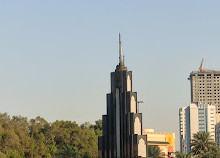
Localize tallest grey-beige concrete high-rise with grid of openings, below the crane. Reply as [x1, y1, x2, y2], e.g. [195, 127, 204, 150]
[189, 69, 220, 115]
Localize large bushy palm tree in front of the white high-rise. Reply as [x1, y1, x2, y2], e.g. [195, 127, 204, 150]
[191, 132, 219, 157]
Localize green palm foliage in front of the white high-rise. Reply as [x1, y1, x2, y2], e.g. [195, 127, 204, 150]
[191, 132, 220, 158]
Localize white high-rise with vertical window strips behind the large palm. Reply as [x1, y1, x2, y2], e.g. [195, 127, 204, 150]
[179, 103, 216, 153]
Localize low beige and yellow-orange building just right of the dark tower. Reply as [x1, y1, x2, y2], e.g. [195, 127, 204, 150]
[143, 129, 175, 158]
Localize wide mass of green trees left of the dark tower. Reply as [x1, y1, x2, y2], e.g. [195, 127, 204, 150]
[0, 113, 102, 158]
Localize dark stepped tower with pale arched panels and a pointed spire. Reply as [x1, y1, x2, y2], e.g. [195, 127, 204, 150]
[98, 34, 147, 158]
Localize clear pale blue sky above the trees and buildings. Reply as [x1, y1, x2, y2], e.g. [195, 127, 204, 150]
[0, 0, 220, 149]
